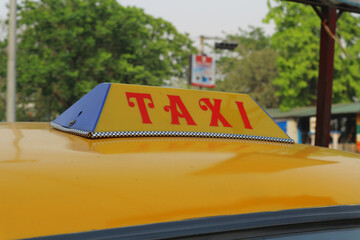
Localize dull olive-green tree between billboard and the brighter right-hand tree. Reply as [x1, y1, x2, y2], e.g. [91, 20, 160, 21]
[217, 27, 279, 108]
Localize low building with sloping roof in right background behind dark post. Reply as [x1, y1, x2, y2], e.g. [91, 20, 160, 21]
[267, 103, 360, 152]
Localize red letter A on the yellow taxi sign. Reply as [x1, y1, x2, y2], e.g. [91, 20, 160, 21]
[164, 95, 196, 125]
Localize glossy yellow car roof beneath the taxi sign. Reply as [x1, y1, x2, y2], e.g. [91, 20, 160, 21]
[0, 123, 360, 239]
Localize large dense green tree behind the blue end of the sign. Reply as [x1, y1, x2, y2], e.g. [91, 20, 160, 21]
[0, 0, 194, 120]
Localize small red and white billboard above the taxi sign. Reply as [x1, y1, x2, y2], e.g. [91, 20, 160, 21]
[190, 55, 215, 88]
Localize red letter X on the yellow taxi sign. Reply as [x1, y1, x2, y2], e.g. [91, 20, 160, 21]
[199, 98, 232, 127]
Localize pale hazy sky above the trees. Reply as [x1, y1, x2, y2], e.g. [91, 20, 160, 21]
[0, 0, 274, 47]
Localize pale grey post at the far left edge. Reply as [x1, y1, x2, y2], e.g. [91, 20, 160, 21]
[6, 0, 16, 122]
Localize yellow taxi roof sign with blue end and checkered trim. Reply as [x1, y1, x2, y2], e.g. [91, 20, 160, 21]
[50, 83, 294, 143]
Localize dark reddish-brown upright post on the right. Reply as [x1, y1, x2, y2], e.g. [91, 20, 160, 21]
[315, 7, 337, 147]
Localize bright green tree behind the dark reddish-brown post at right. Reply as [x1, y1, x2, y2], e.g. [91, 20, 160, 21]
[264, 0, 360, 110]
